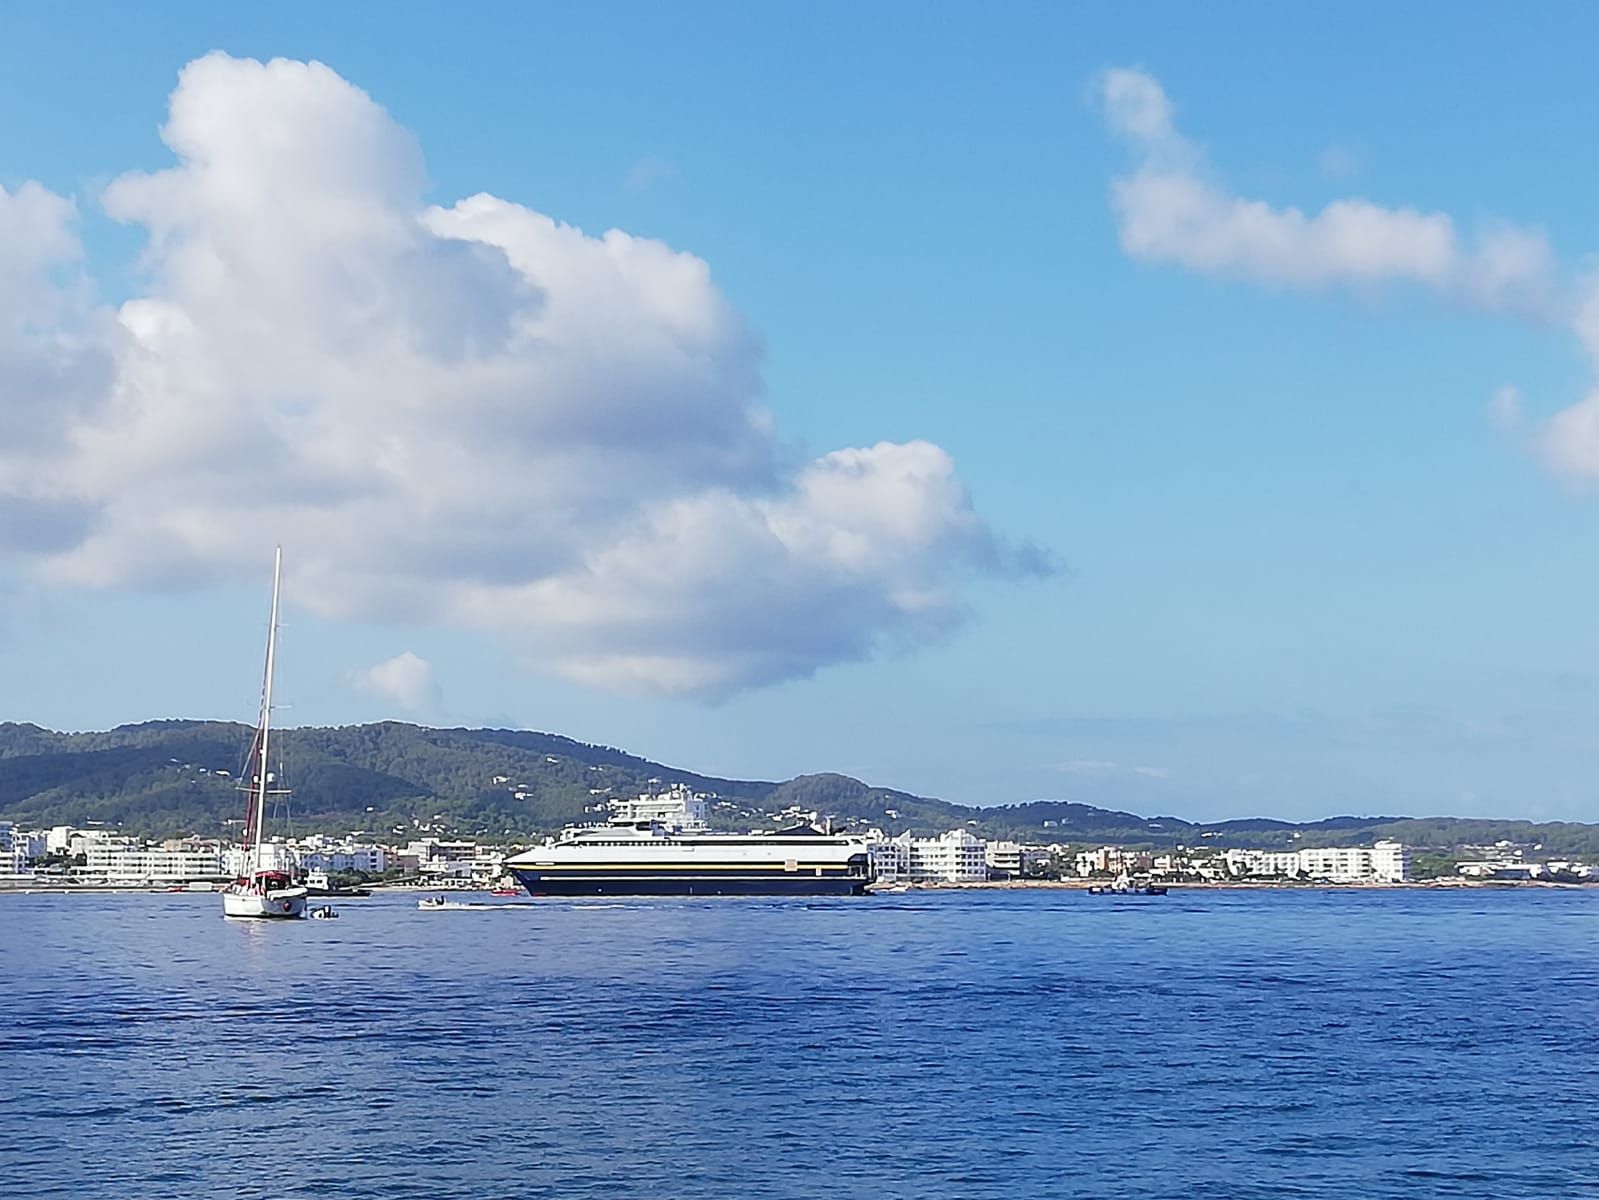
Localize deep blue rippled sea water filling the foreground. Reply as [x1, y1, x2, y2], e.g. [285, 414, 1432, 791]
[0, 890, 1599, 1200]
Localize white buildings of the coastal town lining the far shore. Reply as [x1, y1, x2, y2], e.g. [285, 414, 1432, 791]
[0, 786, 1596, 891]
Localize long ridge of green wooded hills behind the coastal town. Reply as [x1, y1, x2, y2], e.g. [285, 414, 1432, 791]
[0, 720, 1599, 856]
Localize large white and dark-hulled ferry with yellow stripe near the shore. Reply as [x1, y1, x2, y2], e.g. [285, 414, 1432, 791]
[505, 784, 873, 896]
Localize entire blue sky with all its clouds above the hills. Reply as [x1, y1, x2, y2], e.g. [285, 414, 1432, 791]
[0, 3, 1599, 821]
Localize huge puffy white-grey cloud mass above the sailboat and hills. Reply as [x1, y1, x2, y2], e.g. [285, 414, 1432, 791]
[0, 54, 1025, 693]
